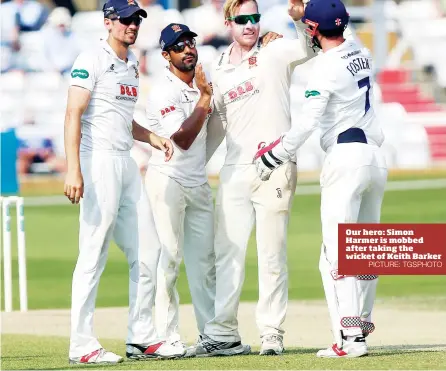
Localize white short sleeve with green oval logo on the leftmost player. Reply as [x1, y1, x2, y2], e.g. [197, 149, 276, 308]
[70, 53, 99, 91]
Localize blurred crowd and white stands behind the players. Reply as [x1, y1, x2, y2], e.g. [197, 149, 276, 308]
[0, 0, 446, 186]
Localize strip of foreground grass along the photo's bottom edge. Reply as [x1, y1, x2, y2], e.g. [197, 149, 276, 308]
[2, 335, 446, 370]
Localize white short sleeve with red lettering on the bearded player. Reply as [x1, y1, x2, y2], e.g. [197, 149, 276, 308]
[146, 86, 187, 138]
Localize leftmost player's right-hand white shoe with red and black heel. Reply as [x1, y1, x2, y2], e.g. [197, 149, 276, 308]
[126, 341, 186, 360]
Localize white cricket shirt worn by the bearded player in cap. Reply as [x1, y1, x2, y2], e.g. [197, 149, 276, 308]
[146, 67, 212, 187]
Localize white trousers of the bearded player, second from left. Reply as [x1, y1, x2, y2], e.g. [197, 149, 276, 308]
[145, 165, 215, 342]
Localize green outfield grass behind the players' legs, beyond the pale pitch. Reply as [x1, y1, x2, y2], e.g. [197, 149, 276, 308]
[2, 189, 446, 309]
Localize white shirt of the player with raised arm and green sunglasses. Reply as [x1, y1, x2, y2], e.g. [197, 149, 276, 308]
[211, 22, 317, 165]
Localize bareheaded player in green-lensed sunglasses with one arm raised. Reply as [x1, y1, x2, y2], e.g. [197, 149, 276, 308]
[202, 0, 316, 355]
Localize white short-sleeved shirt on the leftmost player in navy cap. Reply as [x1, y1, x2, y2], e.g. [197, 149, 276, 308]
[70, 40, 139, 152]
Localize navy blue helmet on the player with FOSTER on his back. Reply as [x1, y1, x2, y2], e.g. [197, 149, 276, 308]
[302, 0, 350, 31]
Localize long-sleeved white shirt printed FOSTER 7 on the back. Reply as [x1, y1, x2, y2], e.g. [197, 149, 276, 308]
[283, 40, 384, 154]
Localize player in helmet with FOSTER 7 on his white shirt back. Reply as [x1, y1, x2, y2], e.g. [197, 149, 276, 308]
[254, 0, 387, 358]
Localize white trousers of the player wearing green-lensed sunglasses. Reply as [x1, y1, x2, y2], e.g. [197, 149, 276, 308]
[205, 162, 297, 342]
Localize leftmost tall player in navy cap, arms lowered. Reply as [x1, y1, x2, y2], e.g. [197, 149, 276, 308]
[64, 0, 184, 364]
